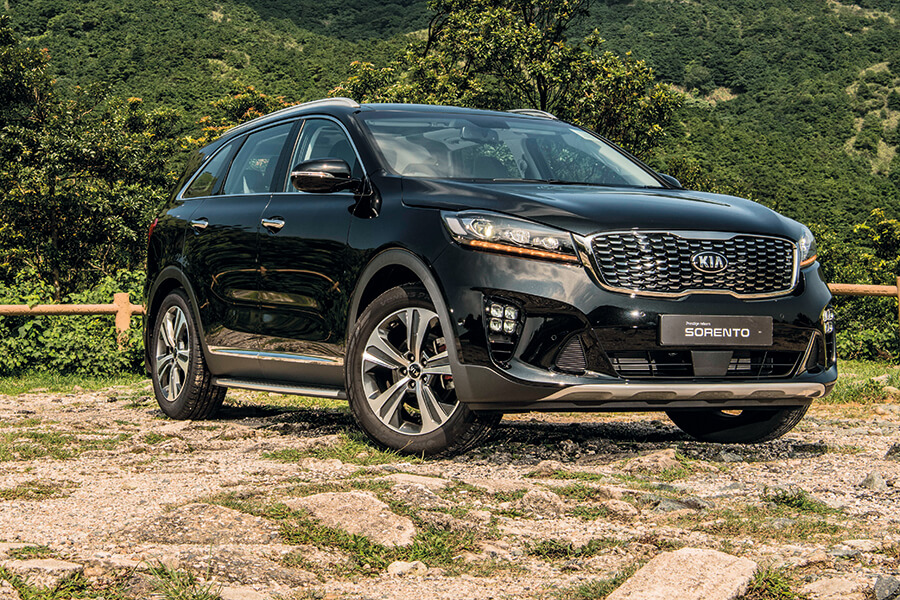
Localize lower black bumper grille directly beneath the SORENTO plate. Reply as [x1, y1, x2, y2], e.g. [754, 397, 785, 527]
[608, 350, 802, 379]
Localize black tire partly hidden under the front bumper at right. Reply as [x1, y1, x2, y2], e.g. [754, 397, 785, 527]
[666, 405, 809, 444]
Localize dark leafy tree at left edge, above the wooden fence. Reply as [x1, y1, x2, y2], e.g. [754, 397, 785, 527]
[0, 21, 178, 300]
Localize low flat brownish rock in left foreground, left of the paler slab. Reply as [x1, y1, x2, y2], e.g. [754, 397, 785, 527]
[122, 503, 280, 546]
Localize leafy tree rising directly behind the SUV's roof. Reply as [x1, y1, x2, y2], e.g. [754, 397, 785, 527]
[332, 0, 680, 153]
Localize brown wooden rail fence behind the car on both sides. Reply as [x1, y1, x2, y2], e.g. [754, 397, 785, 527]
[0, 284, 900, 335]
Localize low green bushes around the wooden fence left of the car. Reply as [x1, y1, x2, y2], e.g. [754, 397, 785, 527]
[0, 270, 144, 376]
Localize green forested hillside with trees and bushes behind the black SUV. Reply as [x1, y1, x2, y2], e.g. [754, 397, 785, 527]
[0, 0, 900, 375]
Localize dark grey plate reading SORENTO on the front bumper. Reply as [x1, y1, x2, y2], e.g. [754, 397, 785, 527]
[659, 315, 772, 348]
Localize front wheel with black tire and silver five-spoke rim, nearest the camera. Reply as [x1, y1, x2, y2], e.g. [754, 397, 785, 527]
[345, 286, 502, 456]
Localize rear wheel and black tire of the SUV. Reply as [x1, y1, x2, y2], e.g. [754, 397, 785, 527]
[150, 290, 226, 420]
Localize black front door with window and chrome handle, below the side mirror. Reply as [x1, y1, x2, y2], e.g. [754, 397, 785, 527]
[253, 117, 362, 386]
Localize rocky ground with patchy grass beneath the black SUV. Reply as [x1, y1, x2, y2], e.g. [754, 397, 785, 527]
[0, 385, 900, 600]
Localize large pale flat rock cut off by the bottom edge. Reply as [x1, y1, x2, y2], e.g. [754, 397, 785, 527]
[607, 548, 757, 600]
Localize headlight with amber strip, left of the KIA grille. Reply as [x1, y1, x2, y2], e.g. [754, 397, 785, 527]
[441, 211, 578, 263]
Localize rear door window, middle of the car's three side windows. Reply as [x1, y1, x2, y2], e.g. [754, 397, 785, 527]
[224, 123, 293, 194]
